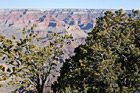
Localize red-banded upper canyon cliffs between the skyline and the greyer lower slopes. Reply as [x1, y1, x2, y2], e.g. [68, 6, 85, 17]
[0, 9, 106, 31]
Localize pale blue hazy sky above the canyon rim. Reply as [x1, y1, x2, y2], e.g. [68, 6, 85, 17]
[0, 0, 140, 10]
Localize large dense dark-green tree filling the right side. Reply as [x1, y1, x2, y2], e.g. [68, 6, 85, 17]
[52, 9, 140, 93]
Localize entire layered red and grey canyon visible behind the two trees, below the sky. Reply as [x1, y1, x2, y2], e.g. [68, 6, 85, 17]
[0, 9, 131, 93]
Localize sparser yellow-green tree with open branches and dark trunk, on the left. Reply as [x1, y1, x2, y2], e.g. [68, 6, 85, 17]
[0, 25, 71, 93]
